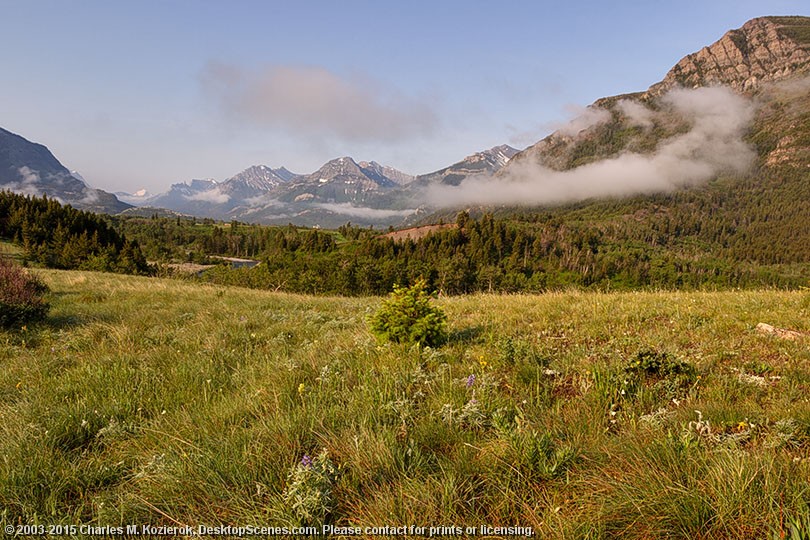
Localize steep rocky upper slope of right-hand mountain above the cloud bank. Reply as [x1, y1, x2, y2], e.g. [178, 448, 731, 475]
[500, 17, 810, 177]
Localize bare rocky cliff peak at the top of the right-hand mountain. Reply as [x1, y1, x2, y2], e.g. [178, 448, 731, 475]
[646, 17, 810, 97]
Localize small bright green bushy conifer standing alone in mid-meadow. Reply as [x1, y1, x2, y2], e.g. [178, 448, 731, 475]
[369, 279, 447, 346]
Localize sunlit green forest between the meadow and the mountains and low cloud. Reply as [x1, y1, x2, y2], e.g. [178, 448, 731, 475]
[116, 179, 810, 295]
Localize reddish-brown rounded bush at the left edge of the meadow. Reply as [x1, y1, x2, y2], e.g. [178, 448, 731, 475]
[0, 257, 50, 328]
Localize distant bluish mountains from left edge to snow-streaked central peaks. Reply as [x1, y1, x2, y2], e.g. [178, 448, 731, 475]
[0, 120, 517, 227]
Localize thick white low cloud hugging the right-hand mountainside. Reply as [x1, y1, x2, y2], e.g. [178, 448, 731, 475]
[425, 87, 755, 207]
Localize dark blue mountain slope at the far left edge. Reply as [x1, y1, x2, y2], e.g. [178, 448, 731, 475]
[0, 128, 131, 214]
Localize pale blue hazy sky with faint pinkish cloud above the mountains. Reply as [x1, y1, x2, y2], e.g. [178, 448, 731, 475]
[0, 0, 810, 192]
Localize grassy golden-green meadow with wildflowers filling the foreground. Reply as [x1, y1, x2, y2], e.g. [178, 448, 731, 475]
[0, 271, 810, 538]
